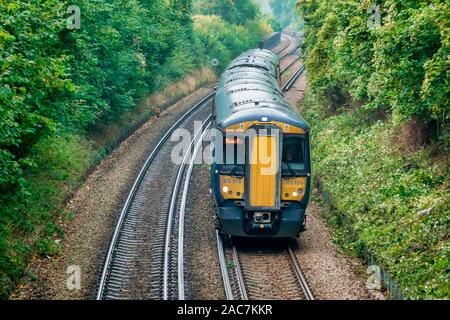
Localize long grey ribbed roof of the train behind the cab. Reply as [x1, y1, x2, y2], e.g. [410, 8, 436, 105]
[215, 49, 309, 131]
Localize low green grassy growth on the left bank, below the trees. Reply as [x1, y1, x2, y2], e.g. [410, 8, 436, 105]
[0, 133, 90, 297]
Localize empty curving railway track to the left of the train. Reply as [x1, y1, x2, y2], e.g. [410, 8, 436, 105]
[97, 31, 302, 300]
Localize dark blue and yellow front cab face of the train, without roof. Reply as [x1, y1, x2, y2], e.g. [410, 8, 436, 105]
[212, 122, 311, 238]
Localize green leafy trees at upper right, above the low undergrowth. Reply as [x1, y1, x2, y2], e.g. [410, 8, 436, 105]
[298, 0, 450, 137]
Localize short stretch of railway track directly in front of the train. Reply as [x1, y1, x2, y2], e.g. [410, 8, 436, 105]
[216, 232, 314, 300]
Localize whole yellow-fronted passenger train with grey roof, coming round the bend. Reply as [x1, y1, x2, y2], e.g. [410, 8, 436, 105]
[211, 49, 312, 238]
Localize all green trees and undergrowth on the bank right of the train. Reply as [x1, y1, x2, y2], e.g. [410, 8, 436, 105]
[298, 0, 450, 299]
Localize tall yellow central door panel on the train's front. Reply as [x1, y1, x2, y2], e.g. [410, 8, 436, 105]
[249, 136, 278, 207]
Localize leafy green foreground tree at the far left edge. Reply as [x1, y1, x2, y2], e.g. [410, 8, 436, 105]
[0, 0, 74, 201]
